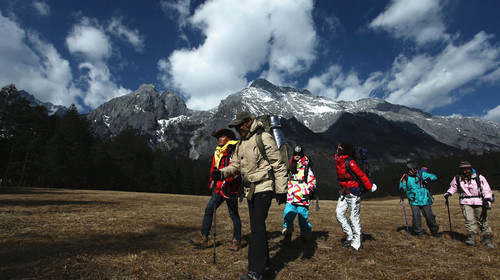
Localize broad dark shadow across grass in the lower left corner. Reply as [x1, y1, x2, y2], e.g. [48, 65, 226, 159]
[0, 224, 199, 279]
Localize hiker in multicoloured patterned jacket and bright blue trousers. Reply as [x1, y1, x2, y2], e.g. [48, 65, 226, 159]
[280, 146, 316, 245]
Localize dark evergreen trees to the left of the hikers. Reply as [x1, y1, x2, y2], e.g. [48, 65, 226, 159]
[0, 85, 210, 194]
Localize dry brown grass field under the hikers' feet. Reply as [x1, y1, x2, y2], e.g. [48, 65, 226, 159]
[0, 188, 500, 280]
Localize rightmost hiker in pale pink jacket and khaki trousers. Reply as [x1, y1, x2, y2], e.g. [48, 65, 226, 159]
[444, 161, 495, 248]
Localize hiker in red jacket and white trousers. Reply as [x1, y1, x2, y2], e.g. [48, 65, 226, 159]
[334, 142, 377, 251]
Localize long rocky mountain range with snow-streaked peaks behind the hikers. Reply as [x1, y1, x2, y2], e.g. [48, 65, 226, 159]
[88, 79, 500, 162]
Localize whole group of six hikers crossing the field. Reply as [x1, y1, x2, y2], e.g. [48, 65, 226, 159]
[188, 111, 494, 280]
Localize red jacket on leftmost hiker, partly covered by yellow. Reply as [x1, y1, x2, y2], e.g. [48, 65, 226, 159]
[207, 141, 241, 199]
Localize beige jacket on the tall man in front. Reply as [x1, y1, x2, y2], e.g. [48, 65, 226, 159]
[220, 119, 287, 199]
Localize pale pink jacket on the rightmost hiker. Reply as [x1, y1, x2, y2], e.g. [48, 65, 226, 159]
[447, 173, 492, 206]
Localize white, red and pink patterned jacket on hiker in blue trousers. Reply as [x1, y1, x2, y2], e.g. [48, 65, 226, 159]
[287, 156, 316, 206]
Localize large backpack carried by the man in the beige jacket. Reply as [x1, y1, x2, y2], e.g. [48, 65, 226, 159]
[255, 115, 289, 169]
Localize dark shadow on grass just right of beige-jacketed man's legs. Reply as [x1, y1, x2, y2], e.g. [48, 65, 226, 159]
[265, 231, 328, 279]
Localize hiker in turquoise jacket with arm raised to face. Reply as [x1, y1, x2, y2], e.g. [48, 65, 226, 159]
[399, 160, 441, 237]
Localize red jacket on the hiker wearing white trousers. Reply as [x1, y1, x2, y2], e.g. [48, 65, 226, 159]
[335, 155, 372, 195]
